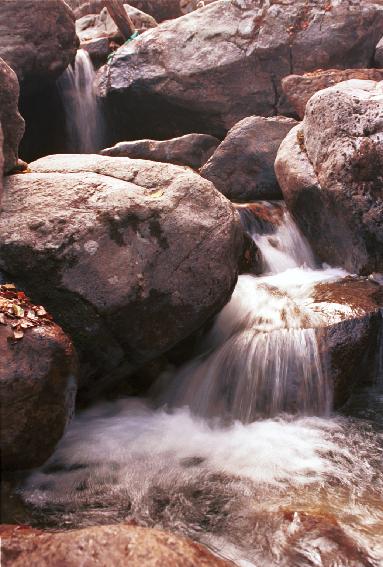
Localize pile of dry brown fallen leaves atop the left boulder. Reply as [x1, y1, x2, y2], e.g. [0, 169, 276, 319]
[0, 284, 52, 341]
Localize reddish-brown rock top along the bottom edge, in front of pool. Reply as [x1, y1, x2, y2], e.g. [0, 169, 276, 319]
[0, 524, 231, 567]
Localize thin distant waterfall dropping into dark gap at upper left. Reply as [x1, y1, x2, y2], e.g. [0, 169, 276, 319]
[57, 49, 103, 153]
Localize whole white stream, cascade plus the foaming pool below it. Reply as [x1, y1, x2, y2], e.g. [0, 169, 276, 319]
[4, 203, 383, 567]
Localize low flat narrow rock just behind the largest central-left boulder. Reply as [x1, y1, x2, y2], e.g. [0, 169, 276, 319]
[100, 134, 219, 169]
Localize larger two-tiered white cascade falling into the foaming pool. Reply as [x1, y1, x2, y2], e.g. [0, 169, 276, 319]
[161, 202, 334, 423]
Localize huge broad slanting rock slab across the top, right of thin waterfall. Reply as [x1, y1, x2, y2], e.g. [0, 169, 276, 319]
[99, 0, 383, 140]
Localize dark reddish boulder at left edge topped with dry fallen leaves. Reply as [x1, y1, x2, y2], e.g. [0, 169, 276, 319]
[0, 284, 76, 470]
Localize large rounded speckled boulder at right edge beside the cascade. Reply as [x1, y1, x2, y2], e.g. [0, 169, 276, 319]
[275, 80, 383, 274]
